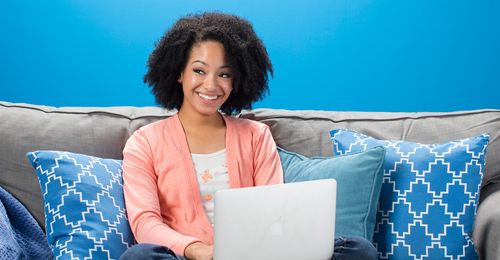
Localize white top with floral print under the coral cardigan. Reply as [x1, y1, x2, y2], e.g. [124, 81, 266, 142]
[191, 149, 229, 226]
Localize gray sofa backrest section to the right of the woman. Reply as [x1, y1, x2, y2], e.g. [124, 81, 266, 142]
[242, 109, 500, 197]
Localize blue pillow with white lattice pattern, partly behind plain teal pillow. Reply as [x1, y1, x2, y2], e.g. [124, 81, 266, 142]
[330, 129, 489, 259]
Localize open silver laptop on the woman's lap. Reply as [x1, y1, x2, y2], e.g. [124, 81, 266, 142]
[214, 179, 337, 260]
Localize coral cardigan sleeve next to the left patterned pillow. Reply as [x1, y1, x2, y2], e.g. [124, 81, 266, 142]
[123, 129, 200, 255]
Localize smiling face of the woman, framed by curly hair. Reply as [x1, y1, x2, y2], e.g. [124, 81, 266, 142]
[179, 41, 233, 116]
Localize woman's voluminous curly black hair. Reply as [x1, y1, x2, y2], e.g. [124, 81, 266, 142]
[144, 12, 273, 114]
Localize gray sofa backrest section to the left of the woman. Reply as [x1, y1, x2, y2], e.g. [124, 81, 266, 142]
[0, 102, 173, 227]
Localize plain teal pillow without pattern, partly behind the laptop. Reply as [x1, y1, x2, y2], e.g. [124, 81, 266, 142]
[278, 147, 385, 240]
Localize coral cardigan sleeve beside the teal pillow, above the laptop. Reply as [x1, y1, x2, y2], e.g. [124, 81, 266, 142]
[254, 125, 283, 186]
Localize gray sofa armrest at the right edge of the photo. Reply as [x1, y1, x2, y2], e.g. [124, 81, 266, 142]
[473, 190, 500, 260]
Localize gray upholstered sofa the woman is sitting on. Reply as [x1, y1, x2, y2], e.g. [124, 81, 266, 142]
[0, 102, 500, 259]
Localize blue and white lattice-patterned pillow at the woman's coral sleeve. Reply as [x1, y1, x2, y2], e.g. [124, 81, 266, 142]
[27, 151, 134, 259]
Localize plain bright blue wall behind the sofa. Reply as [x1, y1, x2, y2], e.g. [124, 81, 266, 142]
[0, 0, 500, 111]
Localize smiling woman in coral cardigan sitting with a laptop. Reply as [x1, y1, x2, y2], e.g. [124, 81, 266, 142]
[122, 13, 376, 259]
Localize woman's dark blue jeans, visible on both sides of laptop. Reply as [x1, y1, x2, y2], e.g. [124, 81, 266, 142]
[120, 237, 377, 260]
